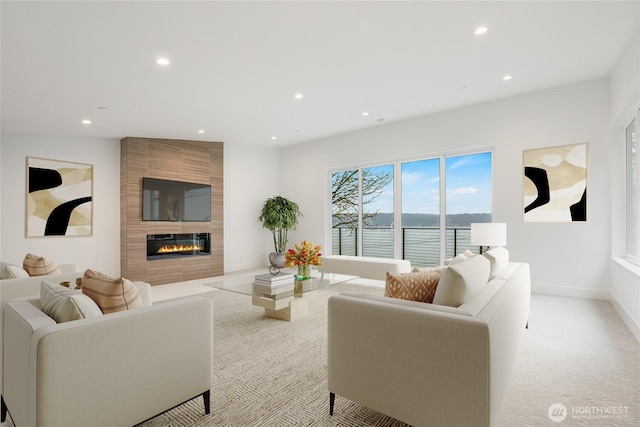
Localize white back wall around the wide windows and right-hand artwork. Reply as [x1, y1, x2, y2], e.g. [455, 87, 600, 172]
[281, 78, 611, 299]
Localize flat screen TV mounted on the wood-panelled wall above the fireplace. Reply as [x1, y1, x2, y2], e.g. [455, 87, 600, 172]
[142, 178, 211, 222]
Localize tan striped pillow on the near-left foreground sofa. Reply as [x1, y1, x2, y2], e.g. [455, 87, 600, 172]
[82, 270, 142, 314]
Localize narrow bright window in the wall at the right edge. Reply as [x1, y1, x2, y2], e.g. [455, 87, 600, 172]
[626, 116, 640, 265]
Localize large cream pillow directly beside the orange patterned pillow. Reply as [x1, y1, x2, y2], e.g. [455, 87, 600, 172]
[433, 256, 490, 307]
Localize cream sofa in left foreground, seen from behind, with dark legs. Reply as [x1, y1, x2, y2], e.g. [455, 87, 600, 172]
[1, 296, 213, 427]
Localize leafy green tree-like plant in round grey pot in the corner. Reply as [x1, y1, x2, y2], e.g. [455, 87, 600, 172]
[258, 196, 302, 268]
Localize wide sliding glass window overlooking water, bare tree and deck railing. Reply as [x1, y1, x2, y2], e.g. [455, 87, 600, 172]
[331, 152, 492, 267]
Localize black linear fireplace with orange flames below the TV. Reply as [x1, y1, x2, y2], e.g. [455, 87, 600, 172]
[147, 233, 211, 260]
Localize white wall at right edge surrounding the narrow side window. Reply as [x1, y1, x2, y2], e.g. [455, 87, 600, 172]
[610, 34, 640, 341]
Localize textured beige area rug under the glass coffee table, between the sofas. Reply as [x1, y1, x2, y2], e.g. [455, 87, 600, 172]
[141, 283, 406, 427]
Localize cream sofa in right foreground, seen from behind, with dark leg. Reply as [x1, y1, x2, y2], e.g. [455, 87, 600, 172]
[327, 254, 531, 427]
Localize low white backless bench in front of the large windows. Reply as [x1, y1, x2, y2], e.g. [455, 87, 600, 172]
[318, 255, 411, 280]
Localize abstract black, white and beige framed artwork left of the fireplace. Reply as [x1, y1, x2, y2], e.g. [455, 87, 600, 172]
[26, 157, 93, 237]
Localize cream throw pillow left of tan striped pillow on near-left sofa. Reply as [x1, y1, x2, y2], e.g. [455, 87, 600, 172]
[40, 280, 102, 323]
